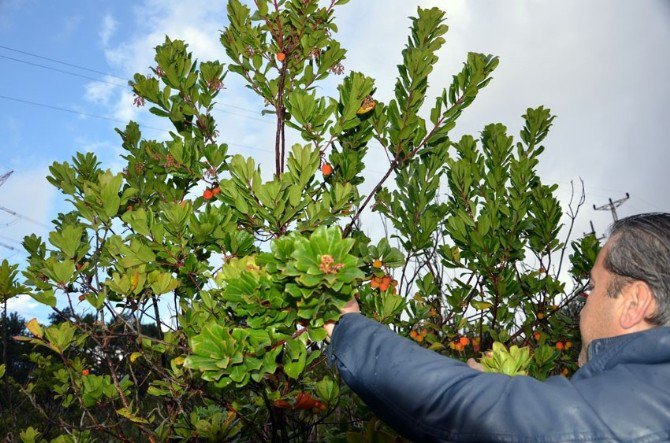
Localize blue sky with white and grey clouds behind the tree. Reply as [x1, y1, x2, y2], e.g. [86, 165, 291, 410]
[0, 0, 670, 319]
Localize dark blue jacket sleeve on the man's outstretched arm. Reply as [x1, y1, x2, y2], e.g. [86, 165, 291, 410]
[327, 314, 613, 442]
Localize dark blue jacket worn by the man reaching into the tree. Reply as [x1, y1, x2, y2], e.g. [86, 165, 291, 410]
[327, 314, 670, 442]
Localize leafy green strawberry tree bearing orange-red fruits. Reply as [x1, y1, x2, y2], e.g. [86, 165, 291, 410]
[0, 0, 598, 441]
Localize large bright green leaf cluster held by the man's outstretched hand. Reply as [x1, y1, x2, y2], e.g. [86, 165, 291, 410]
[184, 227, 364, 387]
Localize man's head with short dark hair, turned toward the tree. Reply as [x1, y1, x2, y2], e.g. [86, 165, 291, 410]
[580, 214, 670, 364]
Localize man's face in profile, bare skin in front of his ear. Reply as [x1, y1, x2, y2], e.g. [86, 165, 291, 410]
[579, 243, 618, 365]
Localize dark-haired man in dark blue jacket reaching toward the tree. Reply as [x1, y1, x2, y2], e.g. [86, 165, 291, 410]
[327, 214, 670, 442]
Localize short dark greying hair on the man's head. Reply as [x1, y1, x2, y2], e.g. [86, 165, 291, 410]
[603, 213, 670, 326]
